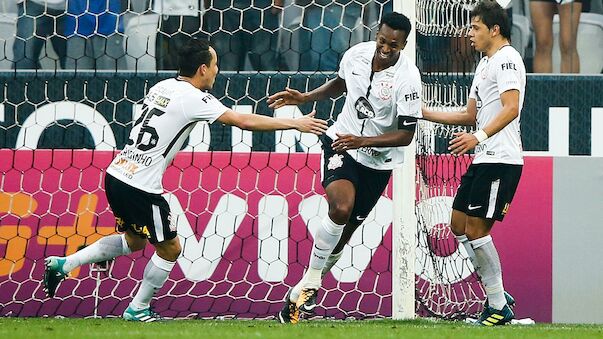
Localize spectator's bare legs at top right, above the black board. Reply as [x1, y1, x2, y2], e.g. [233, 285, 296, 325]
[530, 0, 588, 73]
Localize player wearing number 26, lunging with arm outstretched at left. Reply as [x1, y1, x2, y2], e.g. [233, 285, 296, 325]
[44, 39, 327, 322]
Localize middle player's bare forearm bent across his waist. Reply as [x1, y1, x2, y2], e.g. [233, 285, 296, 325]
[331, 130, 415, 152]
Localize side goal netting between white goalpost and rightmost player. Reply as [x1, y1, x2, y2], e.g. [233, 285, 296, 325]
[416, 0, 485, 319]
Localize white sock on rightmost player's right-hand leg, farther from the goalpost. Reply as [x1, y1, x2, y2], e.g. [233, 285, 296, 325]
[471, 235, 507, 310]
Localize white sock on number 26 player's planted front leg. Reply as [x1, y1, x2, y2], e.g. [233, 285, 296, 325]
[130, 253, 176, 311]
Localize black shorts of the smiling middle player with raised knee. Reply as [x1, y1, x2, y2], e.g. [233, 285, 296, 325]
[321, 136, 392, 225]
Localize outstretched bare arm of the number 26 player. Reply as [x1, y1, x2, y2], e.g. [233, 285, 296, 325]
[218, 110, 328, 135]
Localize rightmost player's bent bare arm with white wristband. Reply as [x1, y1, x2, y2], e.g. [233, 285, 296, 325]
[448, 90, 519, 155]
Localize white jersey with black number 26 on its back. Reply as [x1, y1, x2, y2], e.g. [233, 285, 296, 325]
[107, 79, 228, 194]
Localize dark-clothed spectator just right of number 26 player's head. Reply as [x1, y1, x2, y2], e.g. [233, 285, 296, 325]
[203, 0, 283, 71]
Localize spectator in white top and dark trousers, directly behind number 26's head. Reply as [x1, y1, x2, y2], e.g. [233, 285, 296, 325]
[153, 0, 203, 70]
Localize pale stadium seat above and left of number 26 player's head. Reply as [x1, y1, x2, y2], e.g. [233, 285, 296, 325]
[124, 14, 159, 71]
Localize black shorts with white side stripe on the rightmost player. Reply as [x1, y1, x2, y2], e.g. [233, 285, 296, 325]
[452, 164, 523, 221]
